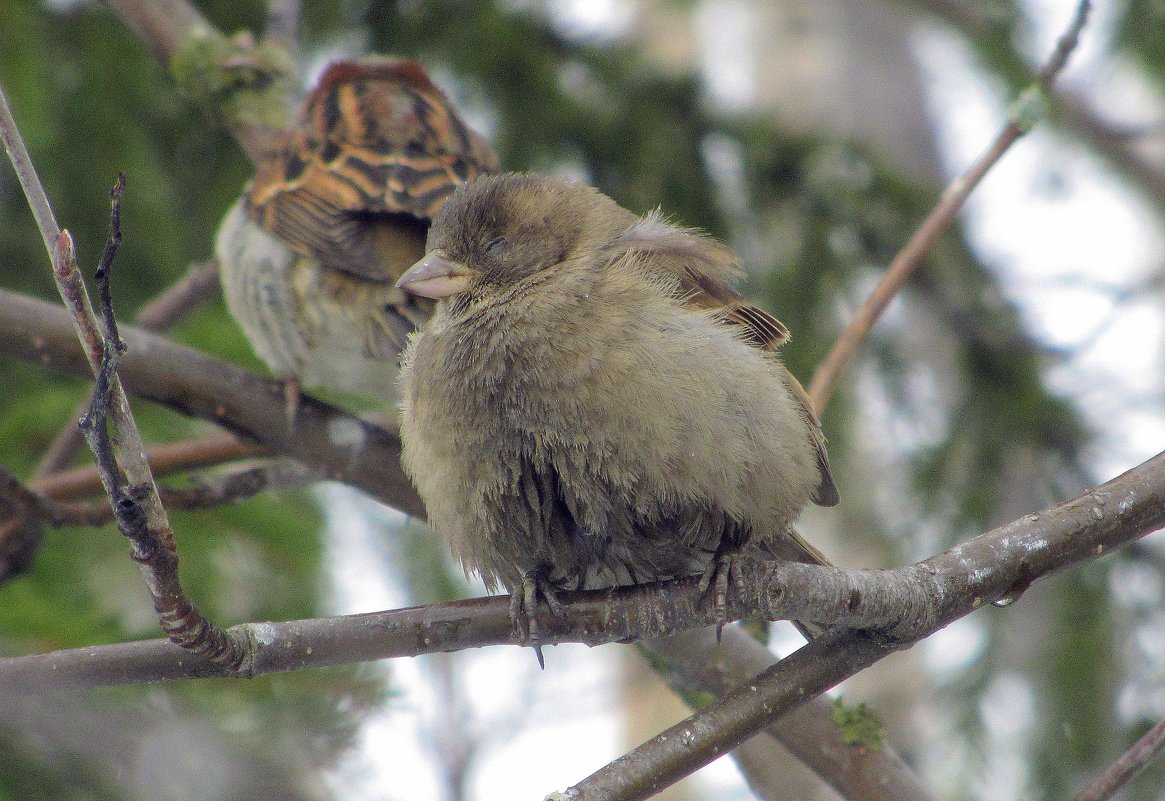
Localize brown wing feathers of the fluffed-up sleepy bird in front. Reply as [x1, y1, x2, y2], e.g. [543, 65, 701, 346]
[608, 211, 838, 506]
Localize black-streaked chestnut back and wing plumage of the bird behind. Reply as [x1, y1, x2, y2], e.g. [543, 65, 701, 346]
[247, 58, 499, 282]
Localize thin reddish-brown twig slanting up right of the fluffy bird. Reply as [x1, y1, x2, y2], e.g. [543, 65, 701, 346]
[809, 0, 1090, 413]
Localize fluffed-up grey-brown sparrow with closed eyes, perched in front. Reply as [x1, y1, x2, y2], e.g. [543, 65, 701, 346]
[397, 173, 838, 662]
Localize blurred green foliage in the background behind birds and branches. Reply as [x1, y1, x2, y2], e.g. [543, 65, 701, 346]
[0, 0, 1165, 801]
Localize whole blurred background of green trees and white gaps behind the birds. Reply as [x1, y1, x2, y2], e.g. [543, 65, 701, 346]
[0, 0, 1165, 800]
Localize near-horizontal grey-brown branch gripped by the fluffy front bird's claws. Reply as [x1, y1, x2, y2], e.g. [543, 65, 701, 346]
[0, 453, 1165, 689]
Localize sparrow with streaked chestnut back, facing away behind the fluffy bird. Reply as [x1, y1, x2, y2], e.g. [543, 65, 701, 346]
[216, 57, 497, 407]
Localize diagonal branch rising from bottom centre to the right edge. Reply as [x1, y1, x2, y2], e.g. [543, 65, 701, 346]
[564, 453, 1165, 801]
